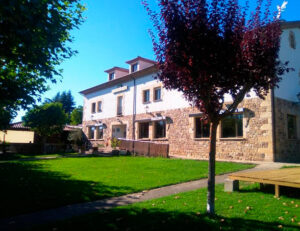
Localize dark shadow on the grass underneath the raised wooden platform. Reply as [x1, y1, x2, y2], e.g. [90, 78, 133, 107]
[239, 183, 300, 198]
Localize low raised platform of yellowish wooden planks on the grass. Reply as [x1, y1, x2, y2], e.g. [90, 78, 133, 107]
[229, 168, 300, 197]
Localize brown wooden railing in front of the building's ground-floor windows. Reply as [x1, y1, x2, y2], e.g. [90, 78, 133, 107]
[119, 139, 169, 158]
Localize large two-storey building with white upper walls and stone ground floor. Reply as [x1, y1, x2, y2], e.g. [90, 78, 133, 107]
[81, 22, 300, 161]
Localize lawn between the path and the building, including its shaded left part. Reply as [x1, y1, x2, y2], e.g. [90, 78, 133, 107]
[0, 157, 253, 217]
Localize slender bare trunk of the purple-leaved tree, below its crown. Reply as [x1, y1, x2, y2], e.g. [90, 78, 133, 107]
[207, 122, 219, 215]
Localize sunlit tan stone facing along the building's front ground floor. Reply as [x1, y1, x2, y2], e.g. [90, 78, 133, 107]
[83, 95, 273, 161]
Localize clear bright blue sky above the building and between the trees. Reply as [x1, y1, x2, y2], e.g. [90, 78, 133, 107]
[14, 0, 300, 121]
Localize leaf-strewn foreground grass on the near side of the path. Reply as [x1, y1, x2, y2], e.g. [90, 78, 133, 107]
[36, 184, 300, 231]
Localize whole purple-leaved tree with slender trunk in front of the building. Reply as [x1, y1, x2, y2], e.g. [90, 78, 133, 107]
[143, 0, 289, 214]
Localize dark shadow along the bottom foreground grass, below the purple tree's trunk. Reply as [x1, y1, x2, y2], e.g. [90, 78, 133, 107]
[38, 208, 298, 231]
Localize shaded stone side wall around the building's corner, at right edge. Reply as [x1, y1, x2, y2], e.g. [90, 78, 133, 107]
[275, 98, 300, 162]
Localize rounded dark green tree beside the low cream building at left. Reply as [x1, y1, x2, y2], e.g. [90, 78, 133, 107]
[23, 103, 67, 137]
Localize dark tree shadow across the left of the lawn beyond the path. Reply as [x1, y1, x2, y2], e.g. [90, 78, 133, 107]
[0, 161, 133, 218]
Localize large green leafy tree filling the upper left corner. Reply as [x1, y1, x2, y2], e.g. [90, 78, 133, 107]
[0, 0, 84, 129]
